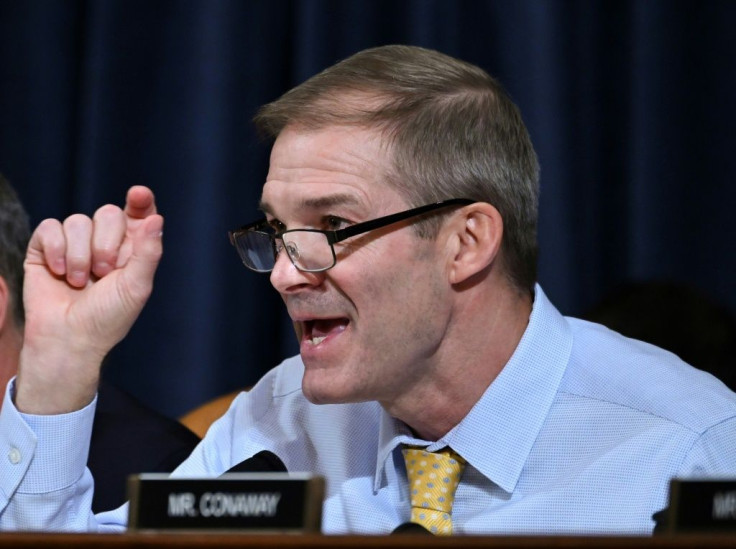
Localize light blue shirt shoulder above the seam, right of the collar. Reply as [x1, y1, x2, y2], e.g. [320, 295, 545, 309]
[562, 317, 736, 433]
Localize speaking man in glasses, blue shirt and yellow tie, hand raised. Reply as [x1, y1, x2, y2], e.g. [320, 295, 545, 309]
[0, 46, 736, 534]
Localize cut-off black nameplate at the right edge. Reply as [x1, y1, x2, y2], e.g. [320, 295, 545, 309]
[667, 479, 736, 532]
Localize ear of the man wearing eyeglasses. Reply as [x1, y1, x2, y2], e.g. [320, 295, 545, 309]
[449, 202, 503, 284]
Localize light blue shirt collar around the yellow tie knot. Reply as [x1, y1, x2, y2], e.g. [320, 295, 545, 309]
[374, 285, 572, 492]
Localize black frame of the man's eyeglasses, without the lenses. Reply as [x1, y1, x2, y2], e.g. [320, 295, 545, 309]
[228, 198, 477, 273]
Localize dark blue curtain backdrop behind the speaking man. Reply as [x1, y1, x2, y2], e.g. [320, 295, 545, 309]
[0, 0, 736, 415]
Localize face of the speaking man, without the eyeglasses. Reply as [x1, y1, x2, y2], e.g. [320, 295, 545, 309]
[262, 127, 451, 403]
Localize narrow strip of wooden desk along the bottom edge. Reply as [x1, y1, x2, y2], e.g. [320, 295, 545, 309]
[0, 533, 736, 549]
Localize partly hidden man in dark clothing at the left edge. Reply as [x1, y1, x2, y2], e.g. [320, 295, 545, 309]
[0, 175, 199, 511]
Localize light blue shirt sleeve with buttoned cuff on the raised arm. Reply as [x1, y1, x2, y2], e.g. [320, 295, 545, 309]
[0, 380, 127, 531]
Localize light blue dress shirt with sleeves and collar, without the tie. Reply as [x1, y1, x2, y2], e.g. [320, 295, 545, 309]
[0, 287, 736, 534]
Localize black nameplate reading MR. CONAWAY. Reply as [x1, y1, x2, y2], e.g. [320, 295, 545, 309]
[128, 473, 325, 533]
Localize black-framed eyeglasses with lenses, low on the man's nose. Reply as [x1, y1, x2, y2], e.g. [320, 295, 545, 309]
[228, 198, 475, 273]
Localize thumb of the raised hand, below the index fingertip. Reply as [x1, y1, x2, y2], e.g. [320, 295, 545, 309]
[125, 215, 164, 304]
